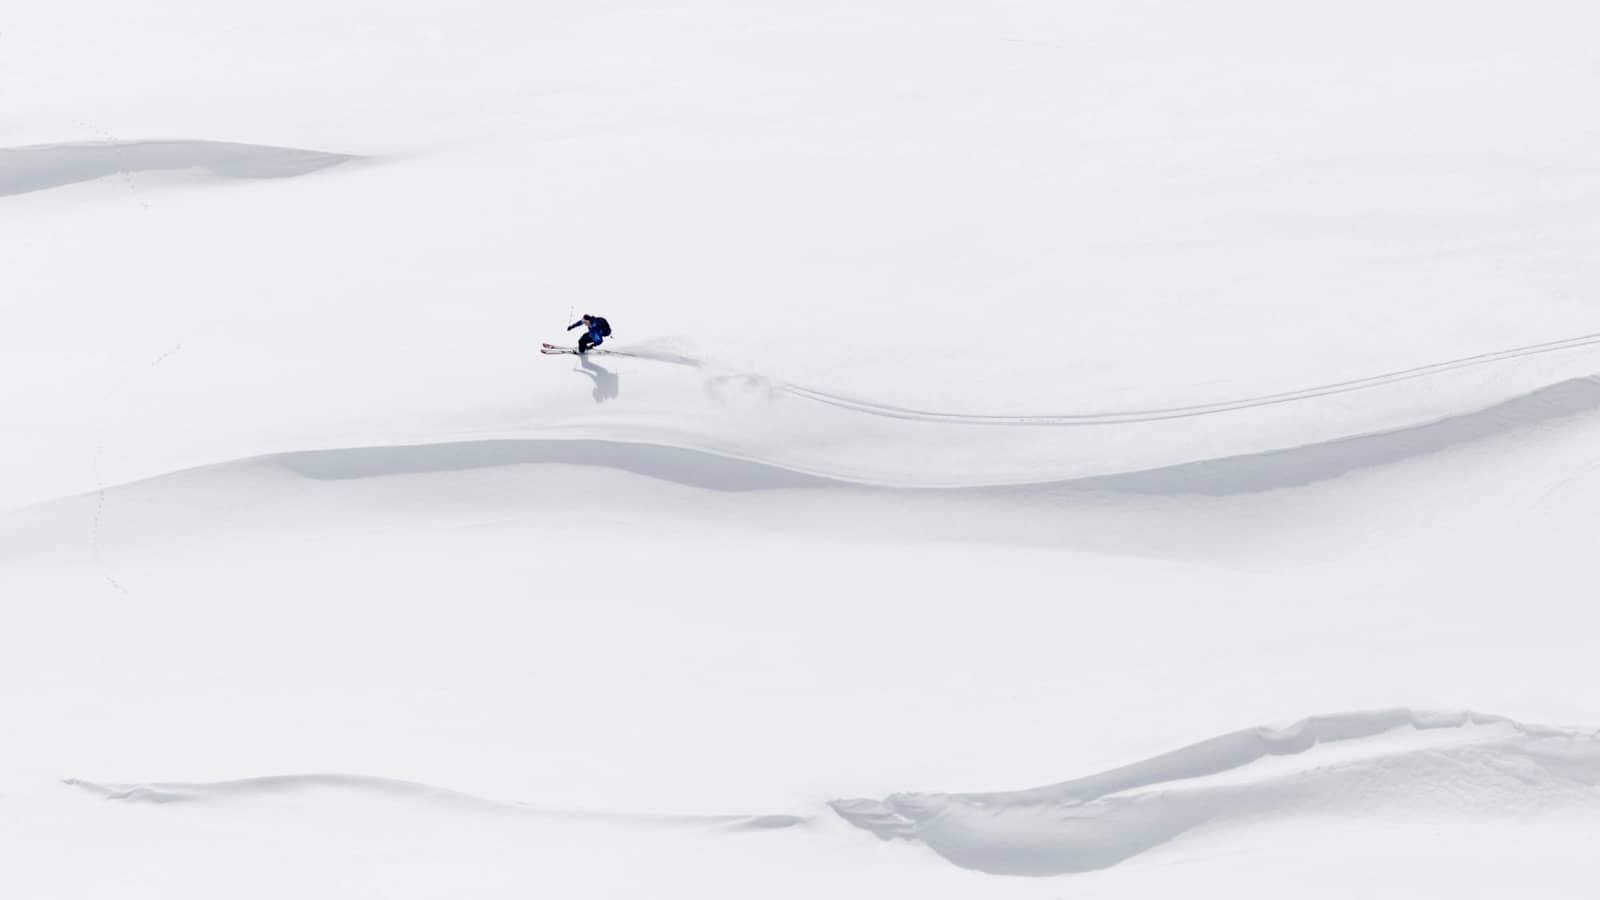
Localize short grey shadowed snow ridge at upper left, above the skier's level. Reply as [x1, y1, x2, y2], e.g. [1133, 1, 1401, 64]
[0, 141, 358, 197]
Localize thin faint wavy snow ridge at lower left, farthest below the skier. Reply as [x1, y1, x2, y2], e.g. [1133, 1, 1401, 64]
[64, 773, 806, 831]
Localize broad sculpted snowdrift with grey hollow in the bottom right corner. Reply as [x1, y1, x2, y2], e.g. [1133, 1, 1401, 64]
[832, 709, 1600, 876]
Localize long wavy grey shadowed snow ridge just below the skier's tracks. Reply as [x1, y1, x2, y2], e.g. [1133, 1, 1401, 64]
[18, 368, 1600, 508]
